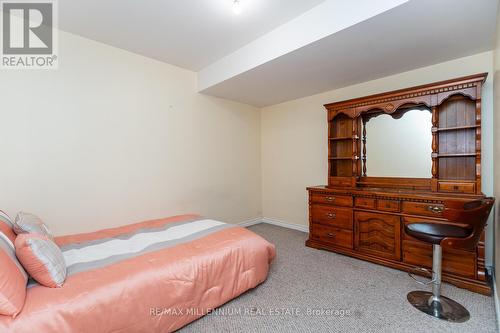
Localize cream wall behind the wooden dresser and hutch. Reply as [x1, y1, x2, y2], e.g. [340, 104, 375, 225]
[261, 52, 493, 265]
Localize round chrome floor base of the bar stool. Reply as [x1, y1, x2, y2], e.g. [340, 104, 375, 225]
[406, 291, 470, 323]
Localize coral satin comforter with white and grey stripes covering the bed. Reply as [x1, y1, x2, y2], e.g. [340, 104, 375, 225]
[0, 215, 275, 333]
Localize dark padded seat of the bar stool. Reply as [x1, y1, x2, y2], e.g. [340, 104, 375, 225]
[405, 223, 471, 245]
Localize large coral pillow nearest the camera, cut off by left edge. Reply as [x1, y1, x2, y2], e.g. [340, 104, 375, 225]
[0, 232, 28, 317]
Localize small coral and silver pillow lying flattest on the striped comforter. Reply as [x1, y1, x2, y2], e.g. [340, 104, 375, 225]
[15, 234, 66, 288]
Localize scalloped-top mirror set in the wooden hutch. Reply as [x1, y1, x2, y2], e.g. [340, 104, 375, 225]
[362, 108, 432, 178]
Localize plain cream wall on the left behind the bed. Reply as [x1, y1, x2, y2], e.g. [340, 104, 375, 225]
[0, 32, 261, 234]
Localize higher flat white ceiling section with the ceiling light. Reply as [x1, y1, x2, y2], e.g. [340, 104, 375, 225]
[58, 0, 324, 71]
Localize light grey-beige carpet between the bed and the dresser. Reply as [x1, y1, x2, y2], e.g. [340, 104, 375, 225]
[181, 224, 496, 333]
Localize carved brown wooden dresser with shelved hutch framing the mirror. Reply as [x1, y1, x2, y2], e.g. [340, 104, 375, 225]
[306, 73, 491, 294]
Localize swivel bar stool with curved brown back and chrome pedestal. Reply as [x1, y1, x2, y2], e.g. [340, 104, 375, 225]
[405, 198, 495, 322]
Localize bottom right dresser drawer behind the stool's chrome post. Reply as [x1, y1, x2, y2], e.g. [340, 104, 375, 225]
[403, 240, 476, 279]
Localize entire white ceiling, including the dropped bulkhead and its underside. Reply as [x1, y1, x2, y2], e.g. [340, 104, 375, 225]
[59, 0, 498, 107]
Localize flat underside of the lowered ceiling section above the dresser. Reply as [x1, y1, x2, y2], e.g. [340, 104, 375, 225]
[203, 0, 497, 107]
